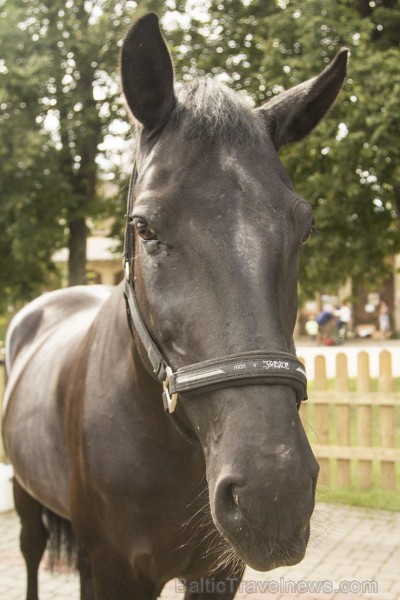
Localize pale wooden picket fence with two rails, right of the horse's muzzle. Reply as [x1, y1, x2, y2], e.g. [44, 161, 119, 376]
[309, 351, 400, 491]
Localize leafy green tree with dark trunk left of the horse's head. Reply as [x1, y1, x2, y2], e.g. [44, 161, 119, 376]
[0, 0, 145, 305]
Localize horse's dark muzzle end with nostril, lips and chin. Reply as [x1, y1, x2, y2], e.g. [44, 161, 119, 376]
[212, 458, 318, 571]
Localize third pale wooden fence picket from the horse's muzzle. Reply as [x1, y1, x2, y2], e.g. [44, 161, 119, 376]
[357, 352, 372, 489]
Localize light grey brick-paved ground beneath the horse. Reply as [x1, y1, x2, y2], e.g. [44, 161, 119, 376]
[0, 504, 400, 600]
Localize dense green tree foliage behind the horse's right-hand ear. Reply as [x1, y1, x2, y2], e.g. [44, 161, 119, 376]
[256, 0, 400, 293]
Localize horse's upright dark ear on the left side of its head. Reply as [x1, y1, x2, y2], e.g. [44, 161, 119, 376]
[121, 13, 175, 131]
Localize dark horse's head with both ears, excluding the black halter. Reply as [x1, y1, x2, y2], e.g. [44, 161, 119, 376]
[121, 14, 347, 570]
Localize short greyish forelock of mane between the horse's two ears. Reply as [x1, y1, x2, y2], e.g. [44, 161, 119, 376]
[170, 77, 265, 143]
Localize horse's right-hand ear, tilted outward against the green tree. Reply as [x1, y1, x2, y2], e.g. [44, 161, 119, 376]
[258, 48, 348, 149]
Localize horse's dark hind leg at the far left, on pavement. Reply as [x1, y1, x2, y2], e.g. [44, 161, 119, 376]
[14, 478, 48, 600]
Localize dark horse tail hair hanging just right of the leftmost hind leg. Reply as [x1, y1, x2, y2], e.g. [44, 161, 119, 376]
[43, 507, 79, 571]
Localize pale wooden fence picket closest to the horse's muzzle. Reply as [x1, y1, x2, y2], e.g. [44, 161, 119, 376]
[314, 355, 329, 486]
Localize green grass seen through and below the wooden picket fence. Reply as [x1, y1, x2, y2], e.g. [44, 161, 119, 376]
[305, 378, 400, 511]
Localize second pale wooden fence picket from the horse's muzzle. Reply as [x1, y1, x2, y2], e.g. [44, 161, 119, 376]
[335, 352, 351, 488]
